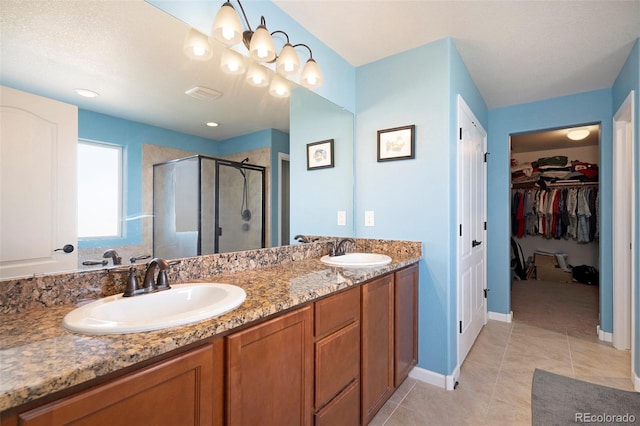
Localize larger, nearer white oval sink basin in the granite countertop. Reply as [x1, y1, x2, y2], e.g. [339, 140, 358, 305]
[62, 283, 247, 334]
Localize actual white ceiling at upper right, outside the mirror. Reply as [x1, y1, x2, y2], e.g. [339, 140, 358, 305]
[274, 0, 640, 109]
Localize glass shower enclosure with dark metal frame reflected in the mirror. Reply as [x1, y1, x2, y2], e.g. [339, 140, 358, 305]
[153, 155, 265, 259]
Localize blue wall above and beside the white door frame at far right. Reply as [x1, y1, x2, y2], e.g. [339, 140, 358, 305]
[612, 39, 640, 374]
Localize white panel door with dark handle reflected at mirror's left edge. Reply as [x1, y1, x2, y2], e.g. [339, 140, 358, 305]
[0, 87, 78, 278]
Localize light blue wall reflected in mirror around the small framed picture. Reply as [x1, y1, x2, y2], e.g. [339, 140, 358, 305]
[289, 90, 354, 241]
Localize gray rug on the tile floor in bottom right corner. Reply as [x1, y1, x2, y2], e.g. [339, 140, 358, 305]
[531, 369, 640, 426]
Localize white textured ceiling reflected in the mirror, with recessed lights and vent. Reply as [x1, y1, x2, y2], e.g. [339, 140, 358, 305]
[0, 0, 289, 140]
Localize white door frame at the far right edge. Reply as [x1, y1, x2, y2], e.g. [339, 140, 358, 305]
[612, 90, 639, 380]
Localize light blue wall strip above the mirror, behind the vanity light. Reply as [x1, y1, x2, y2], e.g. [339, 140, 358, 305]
[147, 0, 355, 112]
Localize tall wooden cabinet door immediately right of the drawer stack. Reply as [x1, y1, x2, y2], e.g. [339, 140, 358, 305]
[360, 274, 394, 424]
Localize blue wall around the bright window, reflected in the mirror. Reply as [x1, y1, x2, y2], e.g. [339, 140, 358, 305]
[78, 109, 216, 248]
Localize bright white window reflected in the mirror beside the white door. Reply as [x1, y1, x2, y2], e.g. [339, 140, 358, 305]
[78, 140, 123, 239]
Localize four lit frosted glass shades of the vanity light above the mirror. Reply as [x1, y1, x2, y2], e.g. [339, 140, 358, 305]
[208, 0, 322, 88]
